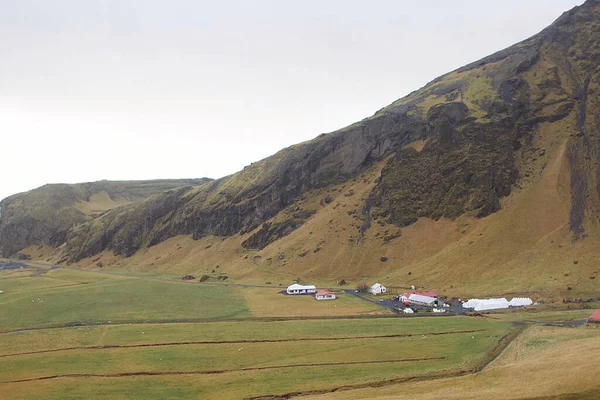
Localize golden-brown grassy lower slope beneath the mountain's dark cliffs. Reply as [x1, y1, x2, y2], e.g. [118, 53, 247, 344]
[68, 126, 600, 301]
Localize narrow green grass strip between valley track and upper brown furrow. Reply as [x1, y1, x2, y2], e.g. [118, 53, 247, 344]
[0, 317, 496, 356]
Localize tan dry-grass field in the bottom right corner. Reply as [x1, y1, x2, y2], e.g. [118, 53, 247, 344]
[308, 326, 600, 400]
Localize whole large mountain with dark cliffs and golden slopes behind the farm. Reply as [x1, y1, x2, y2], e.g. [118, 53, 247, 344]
[0, 0, 600, 295]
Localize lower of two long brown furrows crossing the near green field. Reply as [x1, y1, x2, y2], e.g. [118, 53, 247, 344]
[0, 357, 447, 385]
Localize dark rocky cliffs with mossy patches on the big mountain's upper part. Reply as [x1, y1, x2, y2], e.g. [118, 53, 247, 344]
[0, 0, 600, 268]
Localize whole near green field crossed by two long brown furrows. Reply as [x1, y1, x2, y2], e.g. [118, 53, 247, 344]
[0, 318, 510, 399]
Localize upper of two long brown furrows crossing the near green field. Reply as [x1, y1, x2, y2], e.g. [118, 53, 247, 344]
[0, 329, 486, 358]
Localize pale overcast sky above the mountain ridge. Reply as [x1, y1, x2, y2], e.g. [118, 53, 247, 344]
[0, 0, 583, 199]
